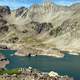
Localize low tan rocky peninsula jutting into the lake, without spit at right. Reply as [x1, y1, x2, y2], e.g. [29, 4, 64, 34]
[15, 48, 64, 58]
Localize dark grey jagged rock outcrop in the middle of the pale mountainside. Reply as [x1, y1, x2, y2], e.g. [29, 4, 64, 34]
[26, 21, 53, 34]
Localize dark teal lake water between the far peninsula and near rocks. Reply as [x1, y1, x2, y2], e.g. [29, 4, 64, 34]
[0, 50, 80, 80]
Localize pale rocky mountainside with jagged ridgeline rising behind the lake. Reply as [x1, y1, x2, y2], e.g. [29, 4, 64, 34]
[0, 2, 80, 51]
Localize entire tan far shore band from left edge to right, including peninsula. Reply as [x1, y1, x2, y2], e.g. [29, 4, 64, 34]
[2, 43, 80, 58]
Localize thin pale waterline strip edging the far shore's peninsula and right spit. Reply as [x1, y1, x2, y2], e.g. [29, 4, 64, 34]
[14, 51, 80, 58]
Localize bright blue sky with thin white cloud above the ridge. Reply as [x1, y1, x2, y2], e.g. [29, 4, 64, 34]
[0, 0, 80, 9]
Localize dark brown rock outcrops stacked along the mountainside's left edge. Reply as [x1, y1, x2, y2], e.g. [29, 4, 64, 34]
[0, 6, 11, 33]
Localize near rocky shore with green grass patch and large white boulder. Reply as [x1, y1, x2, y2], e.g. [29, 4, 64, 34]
[0, 67, 74, 80]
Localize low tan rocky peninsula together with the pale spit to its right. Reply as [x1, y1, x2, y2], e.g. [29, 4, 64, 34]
[15, 49, 80, 58]
